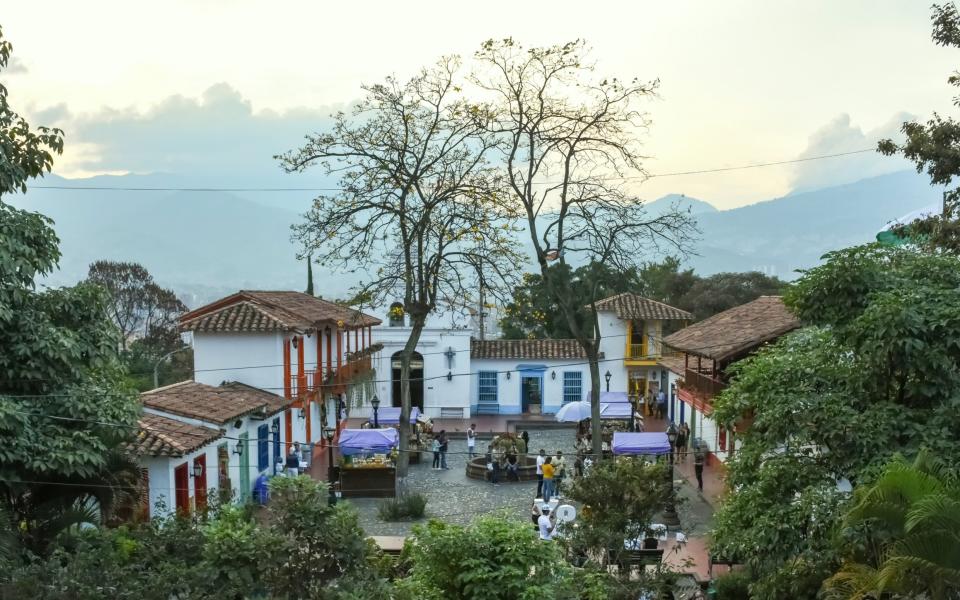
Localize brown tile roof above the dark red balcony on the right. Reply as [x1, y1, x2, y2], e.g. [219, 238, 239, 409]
[663, 296, 800, 361]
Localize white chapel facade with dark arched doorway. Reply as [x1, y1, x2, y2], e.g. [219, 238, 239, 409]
[368, 326, 471, 418]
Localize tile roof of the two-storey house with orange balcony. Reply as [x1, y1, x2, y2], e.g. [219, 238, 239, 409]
[180, 290, 381, 332]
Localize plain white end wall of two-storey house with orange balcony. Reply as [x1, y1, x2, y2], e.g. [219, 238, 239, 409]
[193, 332, 284, 396]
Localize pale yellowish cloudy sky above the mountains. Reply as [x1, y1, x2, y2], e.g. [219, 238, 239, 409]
[0, 0, 960, 208]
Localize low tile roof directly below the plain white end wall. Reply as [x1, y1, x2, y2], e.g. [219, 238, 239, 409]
[140, 381, 286, 425]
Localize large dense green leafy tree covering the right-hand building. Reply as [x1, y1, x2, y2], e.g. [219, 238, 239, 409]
[714, 245, 960, 598]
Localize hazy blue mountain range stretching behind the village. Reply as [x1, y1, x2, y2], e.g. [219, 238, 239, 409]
[4, 171, 941, 306]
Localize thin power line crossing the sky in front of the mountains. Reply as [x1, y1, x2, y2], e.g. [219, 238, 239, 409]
[30, 148, 876, 192]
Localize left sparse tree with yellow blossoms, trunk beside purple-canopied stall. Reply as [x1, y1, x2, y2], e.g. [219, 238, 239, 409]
[277, 58, 517, 491]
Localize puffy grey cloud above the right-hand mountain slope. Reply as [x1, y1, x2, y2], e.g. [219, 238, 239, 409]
[791, 112, 916, 193]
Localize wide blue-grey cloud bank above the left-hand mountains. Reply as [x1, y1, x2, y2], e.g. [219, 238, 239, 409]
[51, 83, 339, 183]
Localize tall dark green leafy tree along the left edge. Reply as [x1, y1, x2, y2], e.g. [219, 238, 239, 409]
[0, 24, 139, 552]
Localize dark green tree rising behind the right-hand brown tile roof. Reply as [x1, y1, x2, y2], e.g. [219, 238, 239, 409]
[675, 271, 787, 321]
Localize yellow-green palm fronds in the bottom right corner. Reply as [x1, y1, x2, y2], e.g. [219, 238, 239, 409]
[826, 451, 960, 600]
